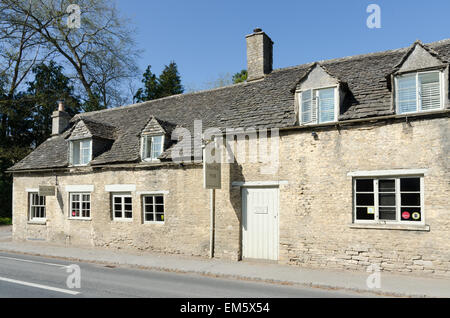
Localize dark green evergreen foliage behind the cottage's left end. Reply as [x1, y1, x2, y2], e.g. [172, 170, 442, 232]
[0, 62, 80, 217]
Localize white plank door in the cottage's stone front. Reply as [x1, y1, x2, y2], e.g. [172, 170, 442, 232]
[242, 188, 279, 260]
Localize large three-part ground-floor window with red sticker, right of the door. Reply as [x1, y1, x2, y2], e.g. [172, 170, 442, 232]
[354, 177, 424, 224]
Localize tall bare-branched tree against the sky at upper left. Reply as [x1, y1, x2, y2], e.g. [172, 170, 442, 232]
[0, 0, 139, 110]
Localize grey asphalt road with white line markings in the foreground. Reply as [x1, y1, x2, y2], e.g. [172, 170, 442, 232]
[0, 252, 368, 298]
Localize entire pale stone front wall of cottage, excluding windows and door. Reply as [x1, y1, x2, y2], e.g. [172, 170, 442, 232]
[13, 117, 450, 276]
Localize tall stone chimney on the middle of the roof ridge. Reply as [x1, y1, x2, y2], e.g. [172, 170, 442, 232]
[245, 28, 273, 82]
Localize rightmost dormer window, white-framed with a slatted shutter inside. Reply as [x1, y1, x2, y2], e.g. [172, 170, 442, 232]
[396, 71, 444, 114]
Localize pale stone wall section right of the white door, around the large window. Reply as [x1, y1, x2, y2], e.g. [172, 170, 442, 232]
[227, 118, 450, 275]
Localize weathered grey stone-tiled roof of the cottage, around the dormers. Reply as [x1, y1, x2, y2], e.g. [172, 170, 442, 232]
[10, 39, 450, 171]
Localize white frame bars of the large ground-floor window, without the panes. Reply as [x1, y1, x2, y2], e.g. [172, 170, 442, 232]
[352, 175, 426, 226]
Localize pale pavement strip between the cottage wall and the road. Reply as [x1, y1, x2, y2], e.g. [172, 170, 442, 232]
[0, 227, 450, 298]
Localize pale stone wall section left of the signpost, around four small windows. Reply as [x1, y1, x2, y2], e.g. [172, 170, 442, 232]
[13, 166, 213, 256]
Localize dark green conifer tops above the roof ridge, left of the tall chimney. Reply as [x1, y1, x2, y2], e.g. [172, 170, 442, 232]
[134, 62, 184, 102]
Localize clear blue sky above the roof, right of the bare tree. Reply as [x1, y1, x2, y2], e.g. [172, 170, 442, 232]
[117, 0, 450, 90]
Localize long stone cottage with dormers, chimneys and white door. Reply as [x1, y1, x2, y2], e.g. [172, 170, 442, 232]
[9, 29, 450, 276]
